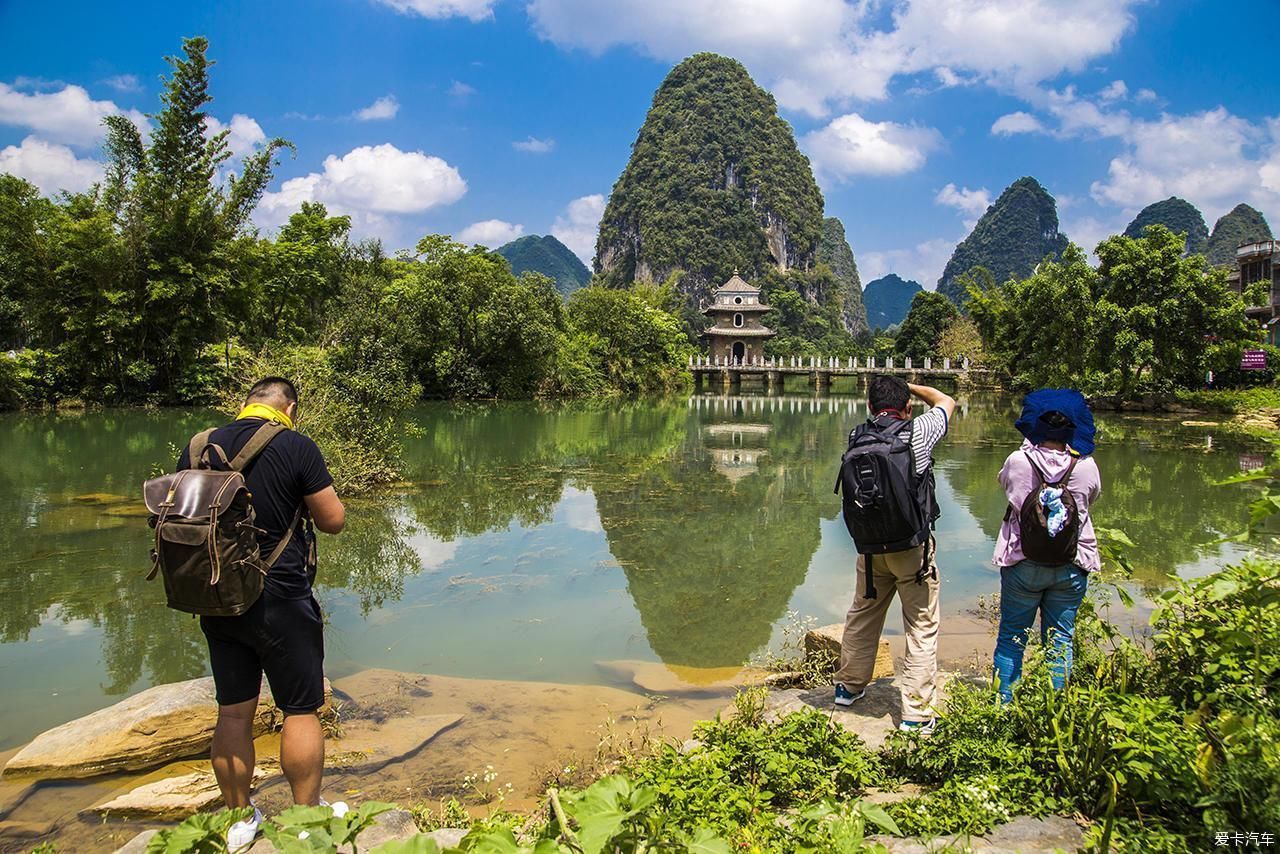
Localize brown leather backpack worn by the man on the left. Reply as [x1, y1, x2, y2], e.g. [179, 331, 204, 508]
[142, 423, 302, 617]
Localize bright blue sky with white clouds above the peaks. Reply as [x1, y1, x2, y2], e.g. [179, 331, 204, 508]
[0, 0, 1280, 288]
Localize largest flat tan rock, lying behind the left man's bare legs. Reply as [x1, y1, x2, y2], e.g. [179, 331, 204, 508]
[4, 676, 330, 780]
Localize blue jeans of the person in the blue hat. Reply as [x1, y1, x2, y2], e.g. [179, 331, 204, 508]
[995, 561, 1089, 703]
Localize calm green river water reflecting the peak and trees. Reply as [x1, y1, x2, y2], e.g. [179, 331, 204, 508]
[0, 394, 1266, 750]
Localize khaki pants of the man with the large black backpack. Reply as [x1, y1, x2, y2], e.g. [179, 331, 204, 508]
[836, 544, 938, 721]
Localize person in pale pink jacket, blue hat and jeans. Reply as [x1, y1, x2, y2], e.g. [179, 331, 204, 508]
[992, 389, 1102, 703]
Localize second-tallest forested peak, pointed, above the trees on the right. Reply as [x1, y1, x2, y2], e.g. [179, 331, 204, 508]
[938, 175, 1068, 305]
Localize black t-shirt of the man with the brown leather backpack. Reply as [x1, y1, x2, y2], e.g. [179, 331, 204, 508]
[178, 419, 333, 599]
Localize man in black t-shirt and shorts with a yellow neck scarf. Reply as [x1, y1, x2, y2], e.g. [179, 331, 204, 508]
[178, 376, 346, 850]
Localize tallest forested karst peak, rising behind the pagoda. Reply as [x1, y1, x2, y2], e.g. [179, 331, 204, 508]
[595, 54, 823, 302]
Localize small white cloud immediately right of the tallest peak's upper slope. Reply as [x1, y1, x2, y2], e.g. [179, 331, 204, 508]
[801, 113, 942, 179]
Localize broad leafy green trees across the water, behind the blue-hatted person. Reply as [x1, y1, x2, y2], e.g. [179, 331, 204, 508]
[968, 225, 1257, 396]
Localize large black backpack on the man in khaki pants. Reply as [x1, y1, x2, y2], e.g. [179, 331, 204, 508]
[836, 419, 938, 599]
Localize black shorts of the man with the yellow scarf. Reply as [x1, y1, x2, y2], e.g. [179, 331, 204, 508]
[200, 590, 324, 714]
